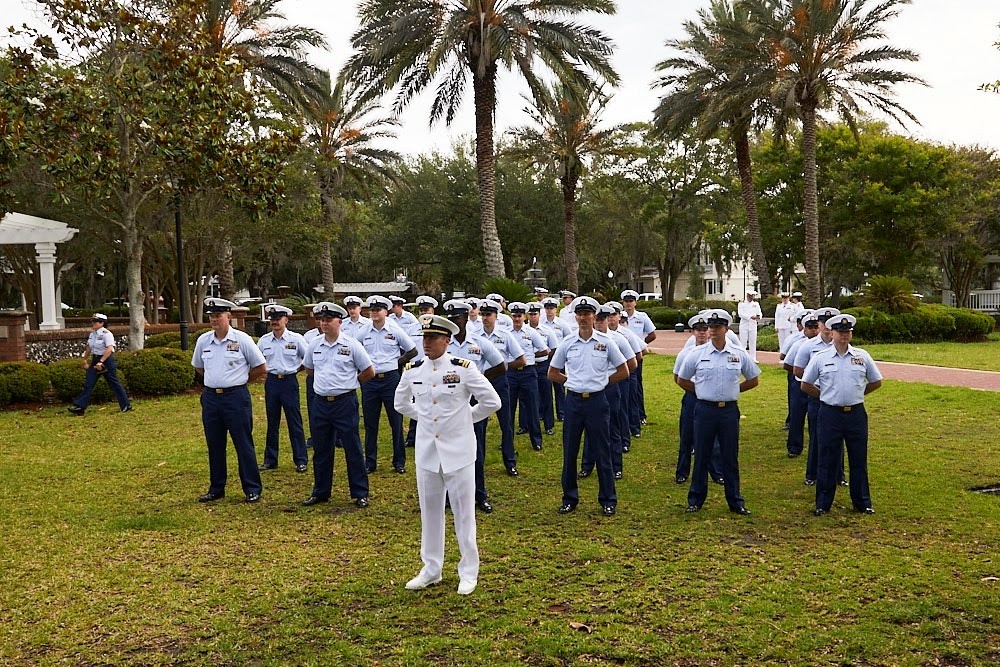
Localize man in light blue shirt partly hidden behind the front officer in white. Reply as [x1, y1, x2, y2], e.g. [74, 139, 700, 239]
[444, 299, 508, 514]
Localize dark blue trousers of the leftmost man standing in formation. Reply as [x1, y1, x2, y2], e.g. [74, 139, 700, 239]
[201, 386, 264, 496]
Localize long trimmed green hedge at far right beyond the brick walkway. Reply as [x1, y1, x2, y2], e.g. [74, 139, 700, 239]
[843, 304, 993, 343]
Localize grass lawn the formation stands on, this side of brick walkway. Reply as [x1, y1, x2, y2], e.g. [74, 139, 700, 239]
[0, 357, 1000, 666]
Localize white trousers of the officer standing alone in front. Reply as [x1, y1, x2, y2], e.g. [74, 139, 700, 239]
[417, 464, 479, 580]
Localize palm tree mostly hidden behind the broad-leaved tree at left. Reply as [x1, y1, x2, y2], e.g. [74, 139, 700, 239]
[196, 0, 329, 298]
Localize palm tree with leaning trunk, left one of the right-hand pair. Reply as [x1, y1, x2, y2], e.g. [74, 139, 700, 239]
[653, 0, 773, 294]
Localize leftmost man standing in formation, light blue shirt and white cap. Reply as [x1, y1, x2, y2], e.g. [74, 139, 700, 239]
[191, 298, 267, 503]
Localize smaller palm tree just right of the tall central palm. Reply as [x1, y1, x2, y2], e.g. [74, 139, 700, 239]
[507, 83, 617, 292]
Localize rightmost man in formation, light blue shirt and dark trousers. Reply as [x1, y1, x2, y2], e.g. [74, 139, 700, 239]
[802, 315, 882, 516]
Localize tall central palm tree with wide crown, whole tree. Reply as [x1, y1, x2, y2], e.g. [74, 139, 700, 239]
[345, 0, 618, 277]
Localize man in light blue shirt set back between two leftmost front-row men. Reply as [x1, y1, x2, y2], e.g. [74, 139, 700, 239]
[257, 304, 309, 472]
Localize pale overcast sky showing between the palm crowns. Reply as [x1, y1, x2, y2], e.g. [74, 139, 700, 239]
[0, 0, 1000, 154]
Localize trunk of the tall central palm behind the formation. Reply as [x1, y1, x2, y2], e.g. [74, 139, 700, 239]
[472, 65, 504, 278]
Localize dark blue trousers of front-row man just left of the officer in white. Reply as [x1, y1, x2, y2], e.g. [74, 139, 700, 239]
[309, 391, 368, 498]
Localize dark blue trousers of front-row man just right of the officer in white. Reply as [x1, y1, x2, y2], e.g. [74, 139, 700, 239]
[562, 391, 618, 507]
